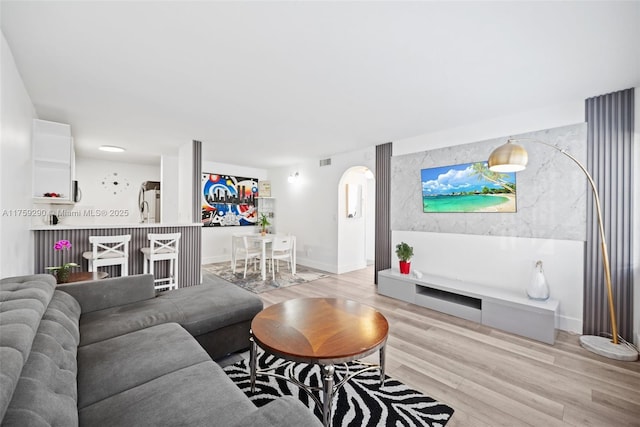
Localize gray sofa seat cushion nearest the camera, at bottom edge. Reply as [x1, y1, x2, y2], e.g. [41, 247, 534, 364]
[79, 361, 258, 427]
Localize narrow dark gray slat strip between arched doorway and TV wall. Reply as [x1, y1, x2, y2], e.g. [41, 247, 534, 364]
[374, 142, 392, 284]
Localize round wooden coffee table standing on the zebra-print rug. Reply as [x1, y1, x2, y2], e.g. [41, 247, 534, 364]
[249, 298, 389, 426]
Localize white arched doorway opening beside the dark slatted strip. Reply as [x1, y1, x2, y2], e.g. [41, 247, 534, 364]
[337, 166, 375, 273]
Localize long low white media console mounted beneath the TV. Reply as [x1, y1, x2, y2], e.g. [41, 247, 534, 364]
[378, 270, 559, 344]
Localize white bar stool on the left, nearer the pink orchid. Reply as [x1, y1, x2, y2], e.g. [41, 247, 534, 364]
[82, 234, 131, 276]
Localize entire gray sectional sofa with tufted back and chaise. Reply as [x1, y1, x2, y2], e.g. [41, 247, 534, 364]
[0, 275, 320, 427]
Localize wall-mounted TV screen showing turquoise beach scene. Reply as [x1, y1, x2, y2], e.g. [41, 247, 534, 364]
[421, 162, 516, 212]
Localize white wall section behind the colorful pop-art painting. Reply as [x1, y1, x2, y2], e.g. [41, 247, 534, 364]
[202, 160, 268, 264]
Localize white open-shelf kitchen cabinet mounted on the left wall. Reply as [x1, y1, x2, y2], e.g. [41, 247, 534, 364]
[32, 119, 75, 204]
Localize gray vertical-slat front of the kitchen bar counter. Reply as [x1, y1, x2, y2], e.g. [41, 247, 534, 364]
[34, 225, 201, 288]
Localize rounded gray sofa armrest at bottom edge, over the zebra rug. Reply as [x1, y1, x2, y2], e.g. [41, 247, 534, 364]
[229, 396, 322, 427]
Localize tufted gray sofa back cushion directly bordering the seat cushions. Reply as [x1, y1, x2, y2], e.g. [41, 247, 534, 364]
[2, 290, 80, 426]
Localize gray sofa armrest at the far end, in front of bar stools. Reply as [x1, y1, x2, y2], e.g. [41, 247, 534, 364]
[56, 274, 156, 313]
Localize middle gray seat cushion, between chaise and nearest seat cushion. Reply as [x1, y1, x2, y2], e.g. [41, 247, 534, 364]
[78, 323, 211, 408]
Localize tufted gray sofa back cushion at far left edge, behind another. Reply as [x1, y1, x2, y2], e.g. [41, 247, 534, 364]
[0, 274, 56, 419]
